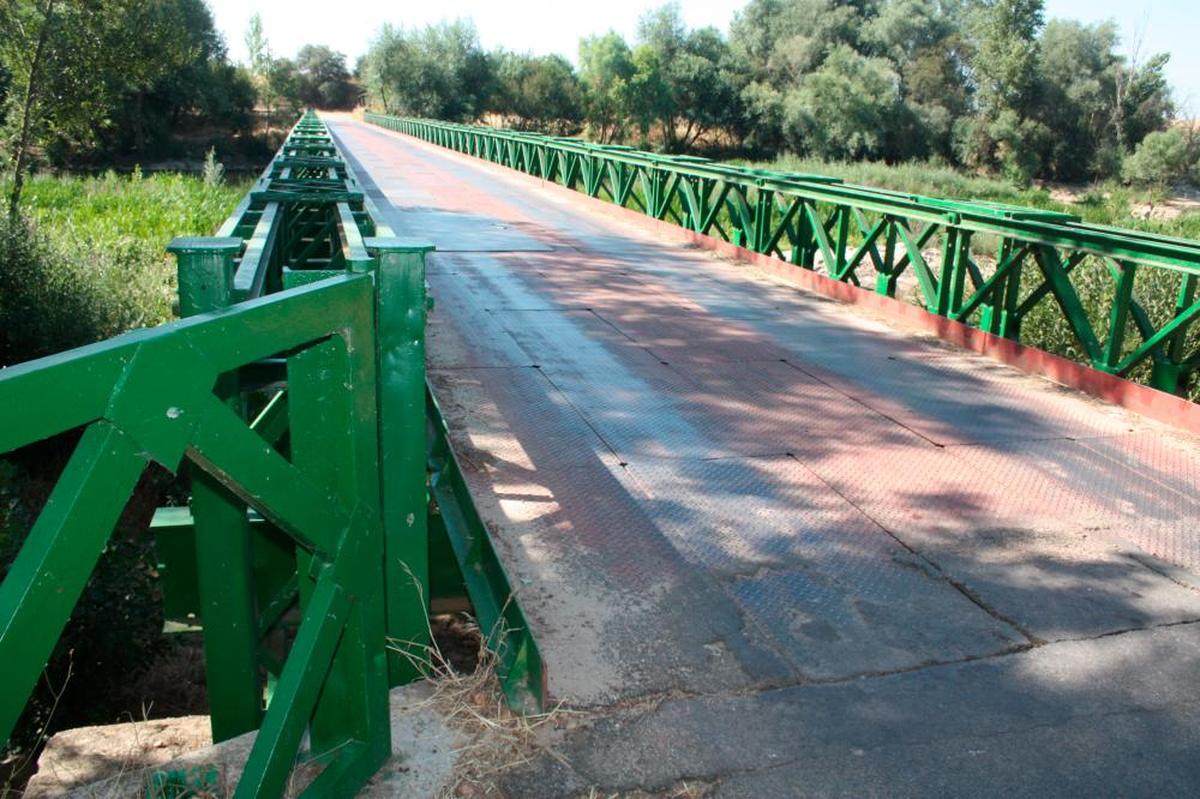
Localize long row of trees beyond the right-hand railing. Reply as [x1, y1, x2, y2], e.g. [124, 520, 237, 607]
[359, 0, 1200, 181]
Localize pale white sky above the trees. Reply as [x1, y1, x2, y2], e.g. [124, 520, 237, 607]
[209, 0, 1200, 116]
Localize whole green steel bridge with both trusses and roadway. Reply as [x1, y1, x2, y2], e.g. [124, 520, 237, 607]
[0, 113, 1200, 797]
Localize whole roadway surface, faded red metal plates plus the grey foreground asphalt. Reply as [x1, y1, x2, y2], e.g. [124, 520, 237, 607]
[331, 118, 1200, 797]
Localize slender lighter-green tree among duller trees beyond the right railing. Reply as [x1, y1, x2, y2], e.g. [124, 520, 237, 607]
[580, 31, 635, 144]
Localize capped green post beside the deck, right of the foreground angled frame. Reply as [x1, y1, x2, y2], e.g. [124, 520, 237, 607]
[364, 238, 433, 685]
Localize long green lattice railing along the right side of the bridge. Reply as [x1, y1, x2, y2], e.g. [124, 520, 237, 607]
[366, 113, 1200, 394]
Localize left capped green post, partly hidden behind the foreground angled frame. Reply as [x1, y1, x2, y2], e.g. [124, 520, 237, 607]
[167, 238, 263, 741]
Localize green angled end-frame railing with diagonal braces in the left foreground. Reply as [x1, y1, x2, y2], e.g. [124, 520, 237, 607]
[0, 275, 390, 795]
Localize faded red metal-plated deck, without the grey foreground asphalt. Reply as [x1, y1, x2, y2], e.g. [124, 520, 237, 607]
[331, 118, 1200, 791]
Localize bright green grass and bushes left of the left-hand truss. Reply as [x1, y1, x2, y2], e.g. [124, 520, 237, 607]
[0, 173, 245, 365]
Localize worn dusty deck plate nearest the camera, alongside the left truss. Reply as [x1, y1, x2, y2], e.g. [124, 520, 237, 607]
[433, 370, 796, 704]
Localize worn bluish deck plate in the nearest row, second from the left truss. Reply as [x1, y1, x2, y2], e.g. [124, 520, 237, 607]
[625, 457, 1026, 679]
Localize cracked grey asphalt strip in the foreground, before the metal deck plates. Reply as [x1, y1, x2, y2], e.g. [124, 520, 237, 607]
[505, 624, 1200, 797]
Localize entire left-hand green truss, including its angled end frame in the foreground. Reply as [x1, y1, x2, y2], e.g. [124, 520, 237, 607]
[0, 112, 544, 797]
